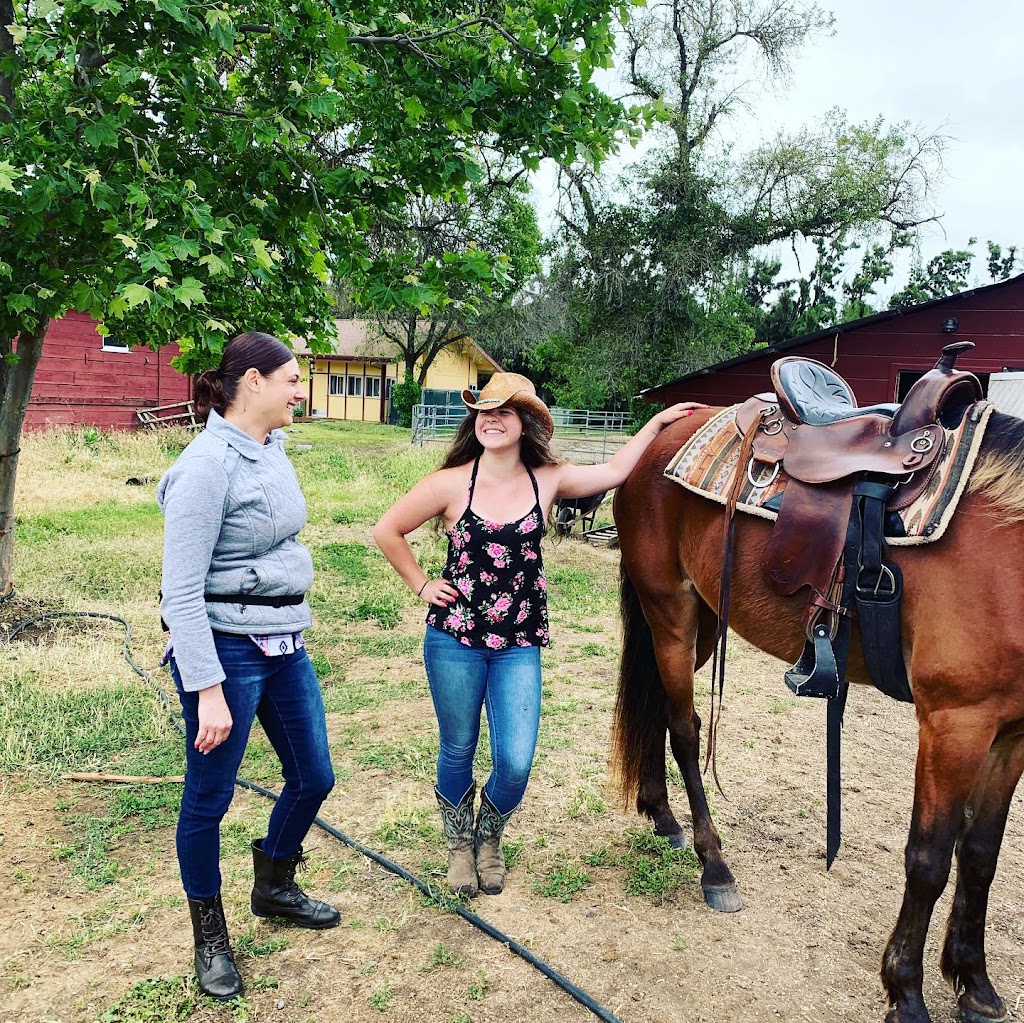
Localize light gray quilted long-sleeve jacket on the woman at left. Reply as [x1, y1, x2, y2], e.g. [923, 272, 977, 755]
[157, 412, 313, 691]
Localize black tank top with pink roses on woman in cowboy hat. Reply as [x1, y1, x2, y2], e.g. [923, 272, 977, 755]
[427, 458, 549, 650]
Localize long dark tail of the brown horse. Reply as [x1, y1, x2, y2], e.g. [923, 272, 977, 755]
[612, 563, 669, 812]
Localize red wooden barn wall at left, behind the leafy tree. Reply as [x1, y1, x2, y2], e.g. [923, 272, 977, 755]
[25, 312, 191, 430]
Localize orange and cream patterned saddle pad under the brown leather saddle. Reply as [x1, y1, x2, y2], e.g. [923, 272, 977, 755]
[665, 401, 993, 546]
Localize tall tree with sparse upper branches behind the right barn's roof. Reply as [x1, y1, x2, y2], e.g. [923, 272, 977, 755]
[540, 0, 943, 400]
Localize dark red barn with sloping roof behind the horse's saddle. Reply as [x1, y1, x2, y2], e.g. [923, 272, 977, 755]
[642, 274, 1024, 406]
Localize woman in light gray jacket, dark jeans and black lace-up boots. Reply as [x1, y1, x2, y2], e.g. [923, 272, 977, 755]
[157, 334, 339, 1000]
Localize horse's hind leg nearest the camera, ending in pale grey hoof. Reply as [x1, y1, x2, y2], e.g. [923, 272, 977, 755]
[644, 584, 742, 912]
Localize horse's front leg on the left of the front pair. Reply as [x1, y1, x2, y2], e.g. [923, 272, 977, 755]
[882, 712, 993, 1023]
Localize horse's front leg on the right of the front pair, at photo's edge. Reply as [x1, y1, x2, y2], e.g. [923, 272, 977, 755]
[941, 739, 1024, 1023]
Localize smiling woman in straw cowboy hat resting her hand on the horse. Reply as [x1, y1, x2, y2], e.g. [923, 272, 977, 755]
[374, 373, 701, 895]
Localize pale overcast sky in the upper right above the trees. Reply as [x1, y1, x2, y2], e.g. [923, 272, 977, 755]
[538, 0, 1024, 284]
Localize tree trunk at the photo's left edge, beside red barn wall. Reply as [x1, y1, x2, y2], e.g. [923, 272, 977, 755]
[0, 321, 49, 596]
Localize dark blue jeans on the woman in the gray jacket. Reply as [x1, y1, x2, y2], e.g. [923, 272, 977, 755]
[171, 632, 334, 899]
